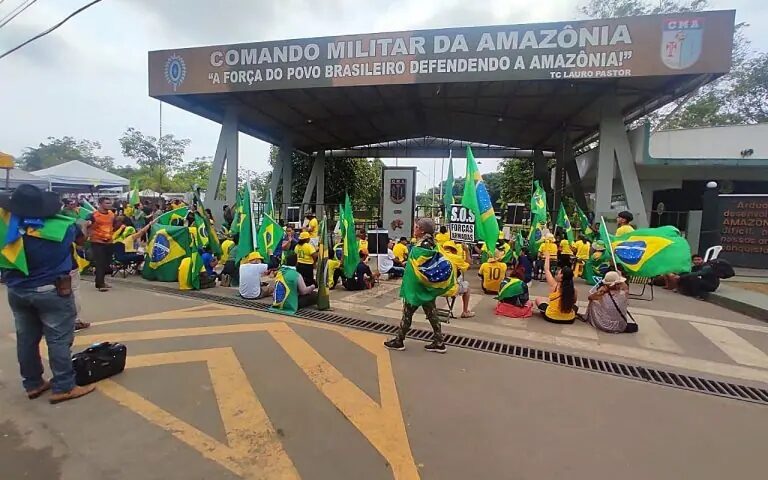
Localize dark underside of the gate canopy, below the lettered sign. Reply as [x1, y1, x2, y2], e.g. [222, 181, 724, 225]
[158, 75, 713, 152]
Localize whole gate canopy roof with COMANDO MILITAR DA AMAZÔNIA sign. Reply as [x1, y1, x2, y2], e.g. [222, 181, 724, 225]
[149, 10, 735, 153]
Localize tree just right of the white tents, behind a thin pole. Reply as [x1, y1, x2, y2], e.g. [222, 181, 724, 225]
[120, 127, 190, 170]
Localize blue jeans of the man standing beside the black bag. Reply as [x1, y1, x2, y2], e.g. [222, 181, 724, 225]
[8, 288, 77, 393]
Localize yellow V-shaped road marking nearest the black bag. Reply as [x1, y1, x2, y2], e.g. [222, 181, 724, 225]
[99, 347, 299, 479]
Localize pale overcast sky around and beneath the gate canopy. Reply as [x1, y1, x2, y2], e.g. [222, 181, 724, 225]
[0, 0, 768, 190]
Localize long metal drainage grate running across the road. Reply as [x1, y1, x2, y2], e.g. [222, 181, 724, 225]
[119, 281, 768, 405]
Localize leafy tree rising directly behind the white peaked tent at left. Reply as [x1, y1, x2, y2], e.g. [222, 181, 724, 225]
[17, 137, 114, 171]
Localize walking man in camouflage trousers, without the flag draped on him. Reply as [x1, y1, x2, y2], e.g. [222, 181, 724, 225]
[384, 218, 445, 353]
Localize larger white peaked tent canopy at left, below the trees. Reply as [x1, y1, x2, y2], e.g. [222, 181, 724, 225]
[31, 160, 129, 191]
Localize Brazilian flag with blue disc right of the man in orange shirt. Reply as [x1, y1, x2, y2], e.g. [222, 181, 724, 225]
[142, 225, 191, 282]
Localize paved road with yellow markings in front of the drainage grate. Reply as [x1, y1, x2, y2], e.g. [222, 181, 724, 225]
[0, 285, 768, 480]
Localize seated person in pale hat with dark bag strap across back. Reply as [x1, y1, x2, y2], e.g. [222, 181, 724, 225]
[586, 271, 637, 333]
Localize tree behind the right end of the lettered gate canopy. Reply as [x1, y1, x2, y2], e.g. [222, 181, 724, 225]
[579, 0, 768, 130]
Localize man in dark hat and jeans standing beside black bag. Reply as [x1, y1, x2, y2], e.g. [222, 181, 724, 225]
[0, 184, 95, 403]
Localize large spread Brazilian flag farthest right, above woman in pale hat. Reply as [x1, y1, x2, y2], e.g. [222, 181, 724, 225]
[610, 225, 691, 277]
